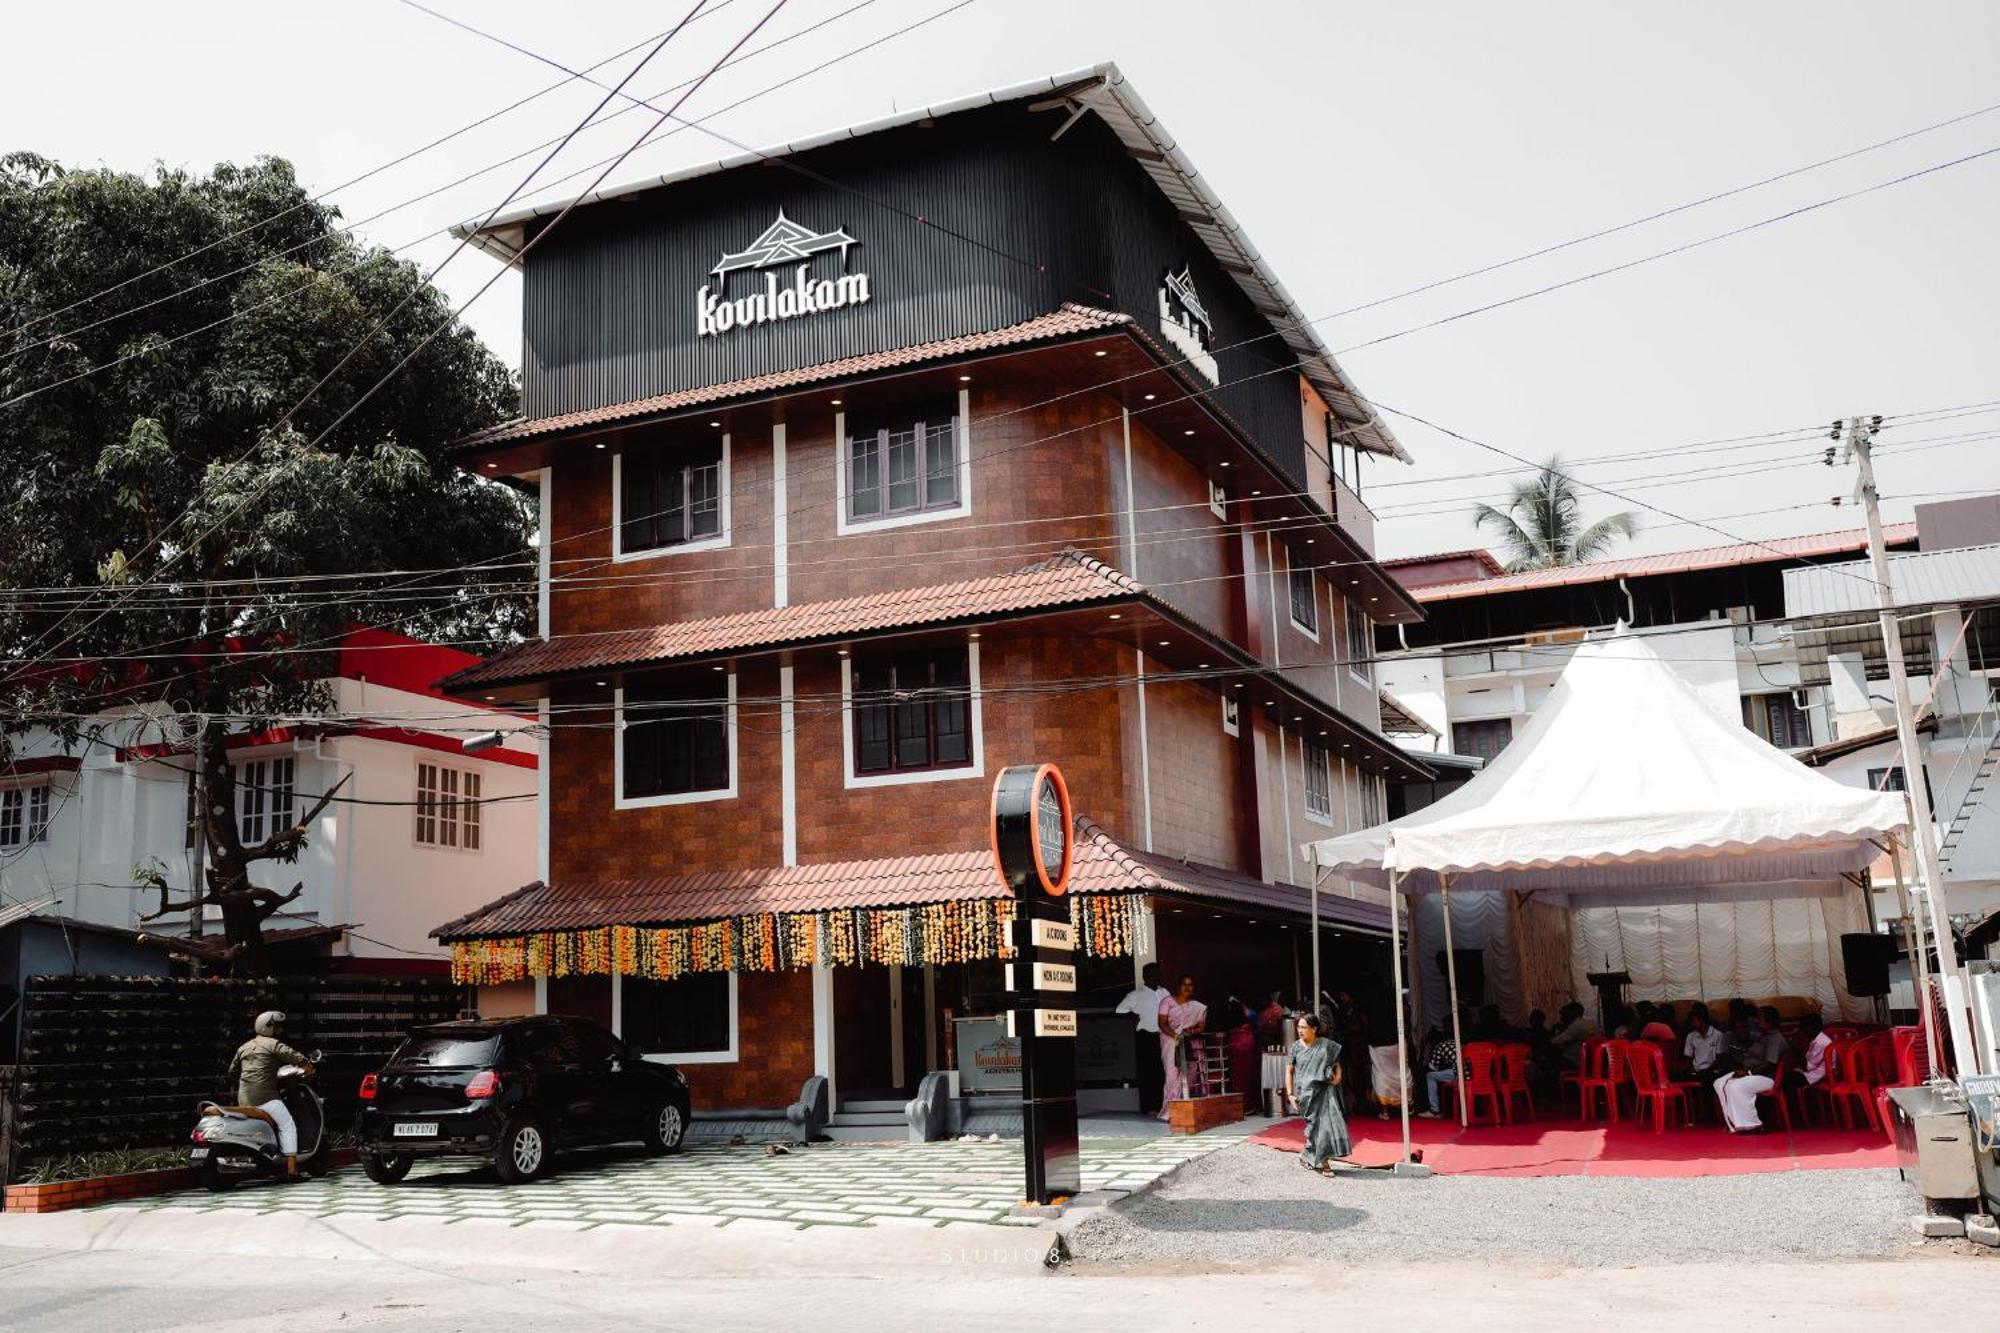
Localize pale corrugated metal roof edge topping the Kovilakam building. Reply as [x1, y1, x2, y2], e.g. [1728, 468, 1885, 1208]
[452, 62, 1410, 462]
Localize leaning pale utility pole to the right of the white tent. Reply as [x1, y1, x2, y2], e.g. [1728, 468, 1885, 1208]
[1834, 416, 1986, 1075]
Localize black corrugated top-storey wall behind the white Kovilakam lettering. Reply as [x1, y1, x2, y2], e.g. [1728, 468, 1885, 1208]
[522, 104, 1304, 482]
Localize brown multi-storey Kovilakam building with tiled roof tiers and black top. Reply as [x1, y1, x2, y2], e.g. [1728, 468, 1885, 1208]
[440, 66, 1422, 1107]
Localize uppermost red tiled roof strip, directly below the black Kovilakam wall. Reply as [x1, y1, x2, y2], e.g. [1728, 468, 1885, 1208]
[450, 302, 1132, 454]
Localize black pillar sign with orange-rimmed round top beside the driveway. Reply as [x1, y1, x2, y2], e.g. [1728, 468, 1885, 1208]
[992, 765, 1082, 1203]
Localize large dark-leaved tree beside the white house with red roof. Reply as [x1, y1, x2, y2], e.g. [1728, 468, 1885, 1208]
[0, 154, 534, 973]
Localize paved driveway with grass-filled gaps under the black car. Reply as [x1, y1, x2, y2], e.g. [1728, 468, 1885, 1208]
[100, 1135, 1234, 1227]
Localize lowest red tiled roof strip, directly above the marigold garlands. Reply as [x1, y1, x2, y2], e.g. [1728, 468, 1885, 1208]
[432, 815, 1388, 941]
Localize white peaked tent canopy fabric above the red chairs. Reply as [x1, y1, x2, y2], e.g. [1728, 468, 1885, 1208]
[1306, 634, 1908, 907]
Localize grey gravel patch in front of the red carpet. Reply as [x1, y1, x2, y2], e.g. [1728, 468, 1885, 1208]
[1068, 1143, 1920, 1267]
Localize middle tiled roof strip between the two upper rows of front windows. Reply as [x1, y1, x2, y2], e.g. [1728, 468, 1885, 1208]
[444, 548, 1146, 691]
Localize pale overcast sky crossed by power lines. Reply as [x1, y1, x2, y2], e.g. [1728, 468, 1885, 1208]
[15, 0, 2000, 554]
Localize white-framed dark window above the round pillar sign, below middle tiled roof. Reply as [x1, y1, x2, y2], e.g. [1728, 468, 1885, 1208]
[854, 646, 972, 775]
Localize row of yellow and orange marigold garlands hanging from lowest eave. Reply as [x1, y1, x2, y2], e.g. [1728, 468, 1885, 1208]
[452, 893, 1136, 985]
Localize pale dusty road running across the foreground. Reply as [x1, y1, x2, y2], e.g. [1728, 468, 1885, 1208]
[0, 1235, 2000, 1333]
